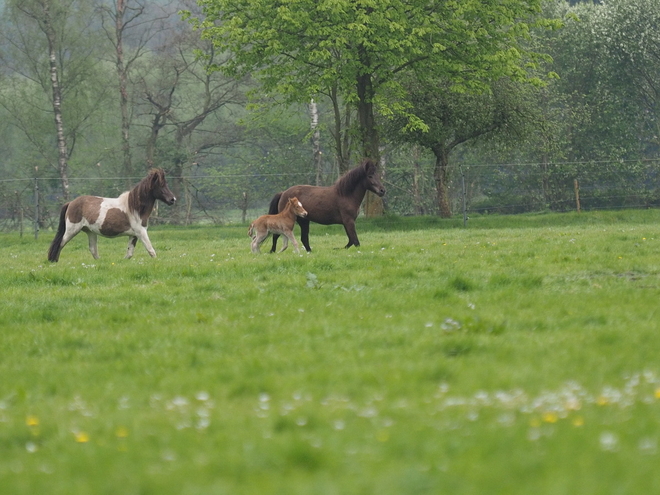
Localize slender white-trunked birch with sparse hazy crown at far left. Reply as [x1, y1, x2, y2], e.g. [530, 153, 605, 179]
[0, 0, 103, 200]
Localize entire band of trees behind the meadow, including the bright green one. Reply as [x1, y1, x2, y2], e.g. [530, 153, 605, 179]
[0, 0, 660, 225]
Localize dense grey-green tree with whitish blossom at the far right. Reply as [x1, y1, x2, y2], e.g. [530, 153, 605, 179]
[480, 0, 657, 210]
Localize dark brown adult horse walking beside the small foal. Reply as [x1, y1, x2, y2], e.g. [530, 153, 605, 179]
[268, 158, 385, 253]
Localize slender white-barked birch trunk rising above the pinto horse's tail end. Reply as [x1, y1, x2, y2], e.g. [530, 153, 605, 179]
[43, 1, 69, 202]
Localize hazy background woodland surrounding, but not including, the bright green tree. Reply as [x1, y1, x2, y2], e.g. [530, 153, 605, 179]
[0, 0, 660, 229]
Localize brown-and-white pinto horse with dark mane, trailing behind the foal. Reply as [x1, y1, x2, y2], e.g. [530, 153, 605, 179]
[48, 169, 176, 262]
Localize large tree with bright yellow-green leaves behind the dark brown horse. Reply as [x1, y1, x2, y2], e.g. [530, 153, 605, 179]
[183, 0, 557, 217]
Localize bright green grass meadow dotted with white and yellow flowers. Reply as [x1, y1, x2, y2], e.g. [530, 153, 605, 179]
[0, 210, 660, 495]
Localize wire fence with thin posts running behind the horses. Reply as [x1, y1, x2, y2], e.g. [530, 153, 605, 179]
[0, 160, 660, 236]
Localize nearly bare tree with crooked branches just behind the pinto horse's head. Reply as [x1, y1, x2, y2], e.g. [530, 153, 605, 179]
[139, 3, 246, 221]
